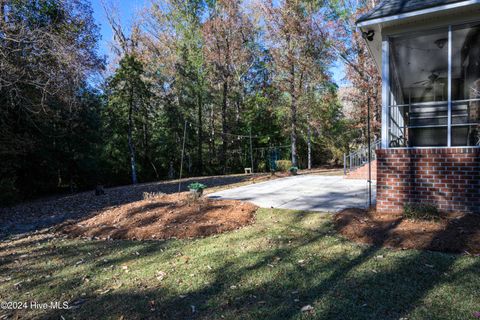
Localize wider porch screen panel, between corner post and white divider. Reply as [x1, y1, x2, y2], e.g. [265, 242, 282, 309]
[388, 29, 448, 147]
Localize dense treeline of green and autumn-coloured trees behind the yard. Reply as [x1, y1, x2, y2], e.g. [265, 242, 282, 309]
[0, 0, 380, 204]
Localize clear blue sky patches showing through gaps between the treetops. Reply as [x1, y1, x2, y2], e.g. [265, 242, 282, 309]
[91, 0, 346, 86]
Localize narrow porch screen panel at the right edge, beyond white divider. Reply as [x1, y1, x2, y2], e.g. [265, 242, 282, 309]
[452, 24, 480, 146]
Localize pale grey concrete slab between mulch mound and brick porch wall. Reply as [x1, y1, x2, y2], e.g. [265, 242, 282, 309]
[208, 175, 376, 212]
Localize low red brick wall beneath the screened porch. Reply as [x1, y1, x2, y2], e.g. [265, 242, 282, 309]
[377, 148, 480, 213]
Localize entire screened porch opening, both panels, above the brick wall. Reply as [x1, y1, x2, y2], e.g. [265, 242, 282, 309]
[383, 24, 480, 148]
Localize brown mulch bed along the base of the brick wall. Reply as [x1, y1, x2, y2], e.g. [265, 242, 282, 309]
[334, 209, 480, 254]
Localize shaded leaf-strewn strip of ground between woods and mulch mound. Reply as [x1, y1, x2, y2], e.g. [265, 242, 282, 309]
[0, 174, 277, 239]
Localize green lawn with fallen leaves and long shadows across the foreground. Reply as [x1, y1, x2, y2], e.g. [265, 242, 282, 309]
[0, 209, 480, 319]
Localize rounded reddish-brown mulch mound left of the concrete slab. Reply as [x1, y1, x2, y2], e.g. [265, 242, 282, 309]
[56, 193, 257, 240]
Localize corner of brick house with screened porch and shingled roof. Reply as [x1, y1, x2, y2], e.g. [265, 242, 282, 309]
[357, 0, 480, 213]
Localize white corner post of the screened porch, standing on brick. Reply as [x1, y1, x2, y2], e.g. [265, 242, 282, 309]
[382, 37, 390, 149]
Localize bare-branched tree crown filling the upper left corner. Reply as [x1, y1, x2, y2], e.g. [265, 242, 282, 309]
[0, 0, 103, 165]
